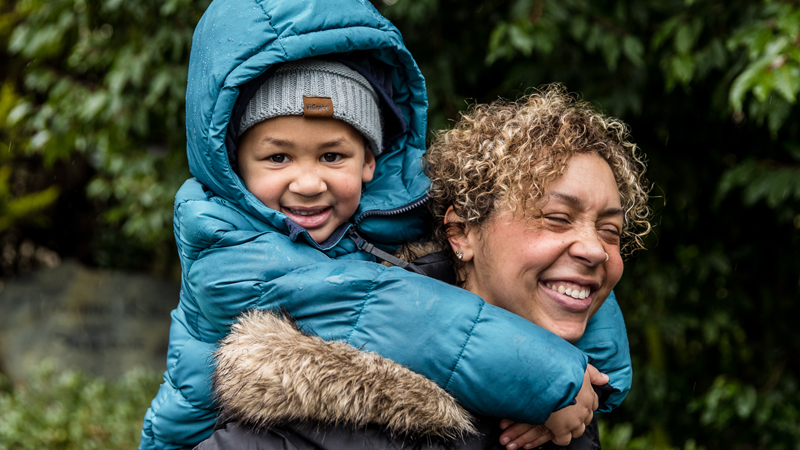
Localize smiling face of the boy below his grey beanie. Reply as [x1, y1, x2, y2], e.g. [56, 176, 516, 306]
[239, 116, 375, 242]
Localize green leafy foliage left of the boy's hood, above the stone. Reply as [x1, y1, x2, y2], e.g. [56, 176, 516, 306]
[5, 0, 207, 248]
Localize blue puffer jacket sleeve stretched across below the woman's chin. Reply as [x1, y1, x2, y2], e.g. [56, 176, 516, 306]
[189, 244, 587, 423]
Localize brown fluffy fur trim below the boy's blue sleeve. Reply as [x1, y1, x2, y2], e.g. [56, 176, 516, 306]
[214, 311, 476, 439]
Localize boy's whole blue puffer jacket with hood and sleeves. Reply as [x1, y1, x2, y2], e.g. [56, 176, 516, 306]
[140, 0, 631, 449]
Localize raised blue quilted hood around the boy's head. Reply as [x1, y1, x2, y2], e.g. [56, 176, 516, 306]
[186, 0, 428, 242]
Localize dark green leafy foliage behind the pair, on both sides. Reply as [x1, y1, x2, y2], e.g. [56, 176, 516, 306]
[0, 0, 800, 450]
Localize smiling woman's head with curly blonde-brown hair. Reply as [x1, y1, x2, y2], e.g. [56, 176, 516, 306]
[425, 86, 650, 442]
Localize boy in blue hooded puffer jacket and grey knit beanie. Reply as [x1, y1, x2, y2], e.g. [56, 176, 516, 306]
[140, 0, 630, 448]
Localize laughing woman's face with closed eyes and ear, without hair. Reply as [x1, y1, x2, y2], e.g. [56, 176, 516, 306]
[451, 154, 624, 342]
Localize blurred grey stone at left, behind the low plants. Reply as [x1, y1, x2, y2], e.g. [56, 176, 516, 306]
[0, 261, 180, 380]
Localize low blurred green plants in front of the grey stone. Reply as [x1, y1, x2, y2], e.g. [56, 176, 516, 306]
[0, 363, 159, 450]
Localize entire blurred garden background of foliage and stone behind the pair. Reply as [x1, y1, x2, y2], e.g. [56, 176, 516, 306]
[0, 0, 800, 450]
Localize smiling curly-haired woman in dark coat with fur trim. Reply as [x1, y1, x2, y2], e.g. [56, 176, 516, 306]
[200, 86, 650, 450]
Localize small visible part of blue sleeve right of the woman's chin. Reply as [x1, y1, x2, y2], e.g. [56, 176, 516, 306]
[575, 292, 633, 412]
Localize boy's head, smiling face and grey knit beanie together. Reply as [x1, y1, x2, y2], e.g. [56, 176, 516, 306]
[237, 59, 383, 246]
